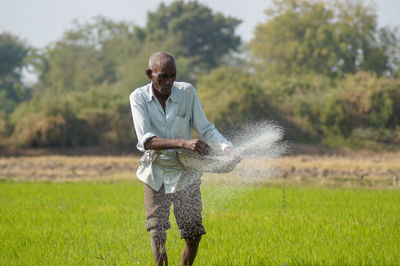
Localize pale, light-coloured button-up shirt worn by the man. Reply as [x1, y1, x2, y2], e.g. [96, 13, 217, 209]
[129, 82, 232, 193]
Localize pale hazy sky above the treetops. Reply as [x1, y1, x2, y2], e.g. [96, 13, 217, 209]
[0, 0, 400, 48]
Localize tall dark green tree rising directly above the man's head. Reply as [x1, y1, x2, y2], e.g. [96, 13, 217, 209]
[145, 1, 240, 71]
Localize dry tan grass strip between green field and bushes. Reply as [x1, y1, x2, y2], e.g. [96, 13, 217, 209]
[0, 153, 400, 187]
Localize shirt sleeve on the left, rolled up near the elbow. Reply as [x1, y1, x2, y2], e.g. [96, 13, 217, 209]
[129, 94, 156, 152]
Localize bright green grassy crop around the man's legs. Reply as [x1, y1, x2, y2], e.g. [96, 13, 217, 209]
[0, 180, 400, 265]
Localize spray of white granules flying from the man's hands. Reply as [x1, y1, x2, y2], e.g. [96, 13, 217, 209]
[190, 122, 288, 220]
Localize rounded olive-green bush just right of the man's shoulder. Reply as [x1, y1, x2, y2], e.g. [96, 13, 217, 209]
[197, 67, 279, 129]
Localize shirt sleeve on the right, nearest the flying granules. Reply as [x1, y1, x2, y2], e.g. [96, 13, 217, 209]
[192, 88, 232, 151]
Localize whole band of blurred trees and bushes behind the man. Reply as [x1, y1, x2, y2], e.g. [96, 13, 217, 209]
[0, 0, 400, 150]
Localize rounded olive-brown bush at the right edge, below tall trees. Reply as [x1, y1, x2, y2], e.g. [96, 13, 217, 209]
[320, 72, 400, 137]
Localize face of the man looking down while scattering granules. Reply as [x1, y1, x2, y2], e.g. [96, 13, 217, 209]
[146, 60, 176, 96]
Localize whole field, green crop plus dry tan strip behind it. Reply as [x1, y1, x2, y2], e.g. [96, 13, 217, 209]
[0, 154, 400, 265]
